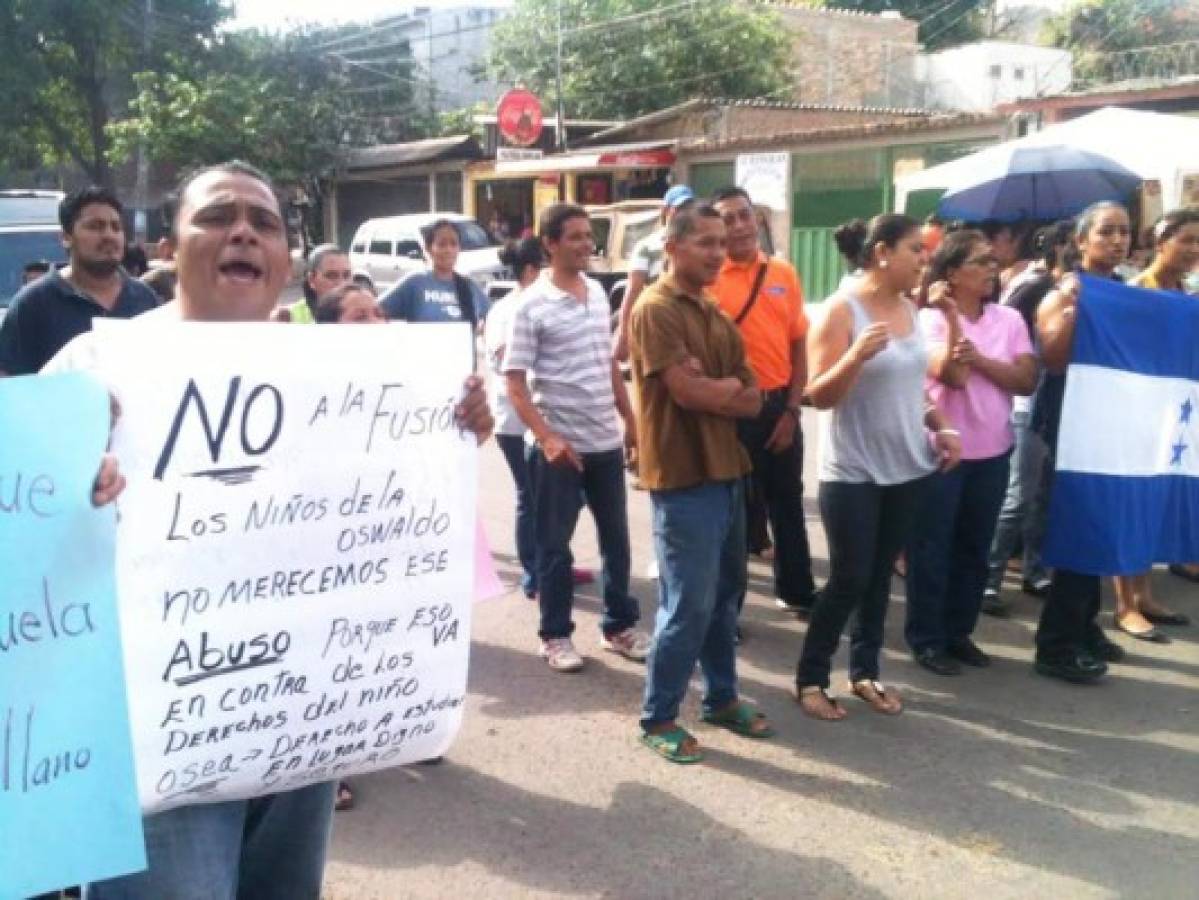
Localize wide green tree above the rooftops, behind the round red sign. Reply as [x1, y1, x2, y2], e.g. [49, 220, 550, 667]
[487, 0, 791, 119]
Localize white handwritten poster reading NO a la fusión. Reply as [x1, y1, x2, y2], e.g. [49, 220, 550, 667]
[97, 321, 476, 811]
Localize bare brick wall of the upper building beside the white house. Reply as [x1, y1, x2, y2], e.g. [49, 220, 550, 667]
[771, 4, 921, 107]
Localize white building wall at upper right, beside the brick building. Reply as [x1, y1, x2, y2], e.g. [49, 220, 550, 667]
[917, 41, 1072, 111]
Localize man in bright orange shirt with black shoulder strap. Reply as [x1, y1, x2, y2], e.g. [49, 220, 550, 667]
[711, 187, 815, 615]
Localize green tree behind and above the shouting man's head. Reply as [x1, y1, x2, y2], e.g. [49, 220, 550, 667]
[108, 30, 432, 244]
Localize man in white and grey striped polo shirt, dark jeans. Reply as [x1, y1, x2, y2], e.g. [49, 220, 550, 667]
[504, 204, 649, 672]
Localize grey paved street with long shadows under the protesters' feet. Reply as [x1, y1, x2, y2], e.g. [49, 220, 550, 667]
[326, 413, 1199, 900]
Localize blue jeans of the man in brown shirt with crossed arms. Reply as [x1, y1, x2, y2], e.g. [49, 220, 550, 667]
[641, 481, 746, 727]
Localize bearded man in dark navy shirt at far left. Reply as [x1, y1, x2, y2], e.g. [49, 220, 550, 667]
[0, 187, 158, 375]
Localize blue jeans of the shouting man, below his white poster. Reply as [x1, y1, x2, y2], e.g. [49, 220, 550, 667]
[84, 781, 337, 900]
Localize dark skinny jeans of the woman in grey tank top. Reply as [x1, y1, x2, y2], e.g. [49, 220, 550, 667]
[795, 477, 928, 688]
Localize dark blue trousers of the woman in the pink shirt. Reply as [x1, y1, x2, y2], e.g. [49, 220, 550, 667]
[904, 453, 1011, 653]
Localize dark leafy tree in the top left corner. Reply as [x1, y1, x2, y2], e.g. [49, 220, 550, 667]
[0, 0, 228, 186]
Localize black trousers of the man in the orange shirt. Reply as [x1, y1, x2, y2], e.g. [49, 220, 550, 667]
[737, 388, 817, 606]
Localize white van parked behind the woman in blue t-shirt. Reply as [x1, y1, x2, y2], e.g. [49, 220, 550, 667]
[350, 212, 506, 295]
